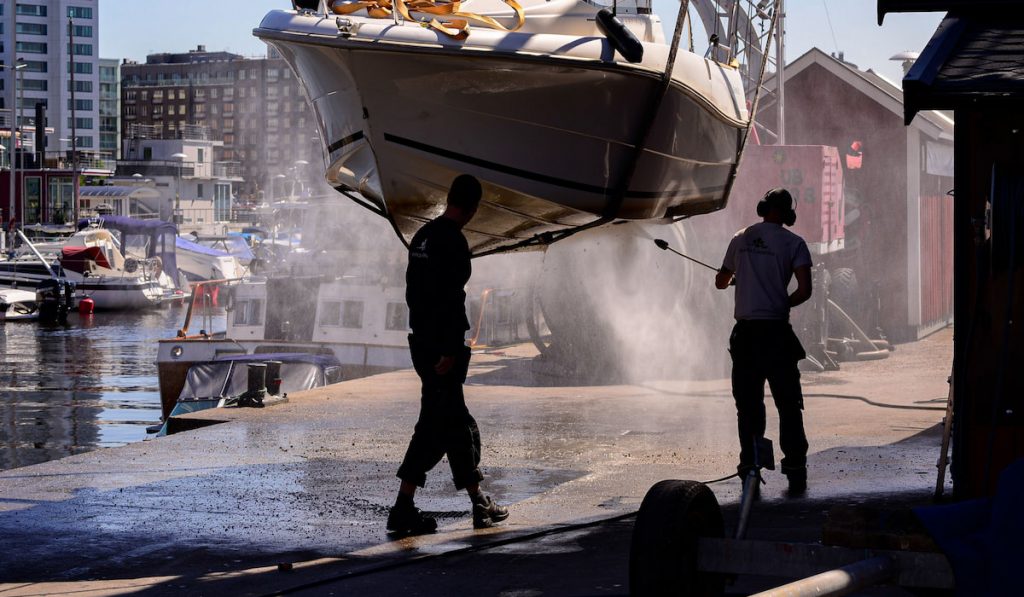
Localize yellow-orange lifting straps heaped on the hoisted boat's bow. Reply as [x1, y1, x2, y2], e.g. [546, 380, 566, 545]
[331, 0, 526, 40]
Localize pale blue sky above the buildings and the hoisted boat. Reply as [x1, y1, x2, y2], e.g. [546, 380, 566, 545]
[99, 0, 942, 81]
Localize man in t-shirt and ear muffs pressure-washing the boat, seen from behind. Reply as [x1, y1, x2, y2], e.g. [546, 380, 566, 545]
[715, 188, 811, 496]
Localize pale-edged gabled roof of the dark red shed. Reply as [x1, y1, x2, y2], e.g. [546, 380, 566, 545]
[762, 48, 953, 138]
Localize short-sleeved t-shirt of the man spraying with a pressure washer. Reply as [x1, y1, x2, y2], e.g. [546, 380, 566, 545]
[722, 222, 811, 319]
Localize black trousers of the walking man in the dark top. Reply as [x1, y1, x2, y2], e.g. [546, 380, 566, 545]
[398, 334, 483, 489]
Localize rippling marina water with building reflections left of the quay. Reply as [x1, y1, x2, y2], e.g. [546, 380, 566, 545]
[0, 305, 224, 469]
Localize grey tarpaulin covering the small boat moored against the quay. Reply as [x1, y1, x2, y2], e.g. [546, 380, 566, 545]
[178, 353, 341, 400]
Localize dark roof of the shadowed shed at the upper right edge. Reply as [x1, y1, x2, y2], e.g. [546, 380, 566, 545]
[903, 11, 1024, 121]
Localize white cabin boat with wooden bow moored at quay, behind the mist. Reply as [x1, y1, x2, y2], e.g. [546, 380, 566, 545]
[157, 195, 412, 419]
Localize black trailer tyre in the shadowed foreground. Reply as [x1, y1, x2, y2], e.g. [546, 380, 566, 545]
[630, 480, 725, 597]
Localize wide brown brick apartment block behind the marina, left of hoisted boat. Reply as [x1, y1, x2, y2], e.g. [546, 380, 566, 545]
[121, 46, 322, 199]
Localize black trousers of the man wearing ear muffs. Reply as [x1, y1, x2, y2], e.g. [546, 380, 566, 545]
[729, 319, 807, 474]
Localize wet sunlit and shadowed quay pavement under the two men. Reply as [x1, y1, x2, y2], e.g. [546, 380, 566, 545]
[0, 330, 952, 596]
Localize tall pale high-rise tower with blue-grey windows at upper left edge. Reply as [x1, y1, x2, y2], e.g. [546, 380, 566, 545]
[0, 0, 99, 158]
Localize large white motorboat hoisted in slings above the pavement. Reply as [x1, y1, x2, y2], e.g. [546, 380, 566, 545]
[254, 0, 750, 254]
